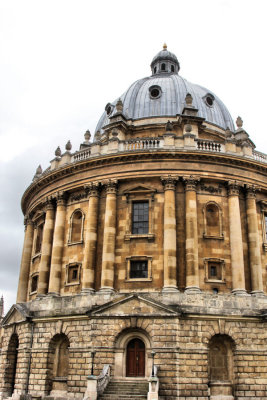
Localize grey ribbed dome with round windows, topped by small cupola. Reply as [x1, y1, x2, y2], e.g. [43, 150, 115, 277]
[96, 49, 234, 131]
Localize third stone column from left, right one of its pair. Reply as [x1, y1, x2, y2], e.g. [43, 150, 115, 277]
[48, 192, 66, 295]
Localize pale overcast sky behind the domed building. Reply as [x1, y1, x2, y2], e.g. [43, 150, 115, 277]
[0, 0, 267, 312]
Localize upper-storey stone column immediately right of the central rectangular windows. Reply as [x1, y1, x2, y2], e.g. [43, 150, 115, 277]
[161, 175, 178, 291]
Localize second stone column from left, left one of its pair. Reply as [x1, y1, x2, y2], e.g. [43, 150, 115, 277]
[37, 196, 55, 296]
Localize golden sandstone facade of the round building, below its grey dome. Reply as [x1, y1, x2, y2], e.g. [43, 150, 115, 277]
[0, 48, 267, 400]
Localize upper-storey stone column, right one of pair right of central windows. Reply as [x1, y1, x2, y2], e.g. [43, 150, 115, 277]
[183, 176, 200, 292]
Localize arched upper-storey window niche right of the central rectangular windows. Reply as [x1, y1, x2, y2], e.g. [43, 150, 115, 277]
[203, 202, 223, 239]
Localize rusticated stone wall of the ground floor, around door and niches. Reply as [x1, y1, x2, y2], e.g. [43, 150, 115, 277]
[0, 293, 267, 400]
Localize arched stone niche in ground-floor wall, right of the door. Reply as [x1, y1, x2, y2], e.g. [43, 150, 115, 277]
[209, 335, 234, 396]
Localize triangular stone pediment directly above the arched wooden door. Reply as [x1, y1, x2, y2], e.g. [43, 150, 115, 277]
[89, 294, 179, 317]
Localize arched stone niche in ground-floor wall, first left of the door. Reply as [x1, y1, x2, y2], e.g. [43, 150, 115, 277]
[48, 334, 70, 391]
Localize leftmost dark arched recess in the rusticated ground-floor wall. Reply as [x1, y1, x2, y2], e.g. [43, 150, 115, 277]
[4, 333, 19, 397]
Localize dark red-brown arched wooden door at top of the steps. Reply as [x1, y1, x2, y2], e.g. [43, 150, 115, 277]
[126, 338, 146, 377]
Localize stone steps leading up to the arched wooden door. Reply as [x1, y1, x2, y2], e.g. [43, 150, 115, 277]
[98, 379, 148, 400]
